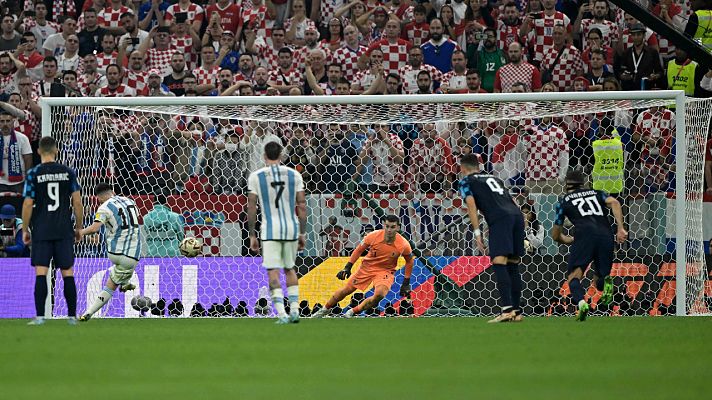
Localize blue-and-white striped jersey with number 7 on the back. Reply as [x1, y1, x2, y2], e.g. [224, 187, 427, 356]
[247, 165, 304, 240]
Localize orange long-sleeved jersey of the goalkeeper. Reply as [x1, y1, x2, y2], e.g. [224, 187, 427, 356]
[349, 229, 413, 277]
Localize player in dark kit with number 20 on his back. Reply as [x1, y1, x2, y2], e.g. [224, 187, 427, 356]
[551, 171, 628, 322]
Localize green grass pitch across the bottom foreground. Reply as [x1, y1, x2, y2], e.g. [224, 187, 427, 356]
[0, 317, 712, 400]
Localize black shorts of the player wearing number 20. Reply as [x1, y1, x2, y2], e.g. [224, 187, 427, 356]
[568, 235, 615, 278]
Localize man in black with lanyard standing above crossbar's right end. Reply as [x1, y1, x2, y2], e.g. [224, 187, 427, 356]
[615, 24, 665, 90]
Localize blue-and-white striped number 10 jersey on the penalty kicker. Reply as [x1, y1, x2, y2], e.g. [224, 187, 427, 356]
[94, 196, 141, 260]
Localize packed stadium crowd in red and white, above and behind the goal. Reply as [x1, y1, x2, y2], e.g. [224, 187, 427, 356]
[0, 0, 712, 203]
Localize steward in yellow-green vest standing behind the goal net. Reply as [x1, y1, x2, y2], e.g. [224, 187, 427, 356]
[591, 127, 625, 195]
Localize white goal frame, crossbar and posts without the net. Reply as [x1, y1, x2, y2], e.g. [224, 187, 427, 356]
[40, 90, 703, 317]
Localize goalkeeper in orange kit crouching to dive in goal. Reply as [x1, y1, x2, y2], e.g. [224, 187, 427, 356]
[314, 215, 414, 318]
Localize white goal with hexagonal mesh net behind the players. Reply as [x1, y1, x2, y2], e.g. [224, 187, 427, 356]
[9, 92, 712, 317]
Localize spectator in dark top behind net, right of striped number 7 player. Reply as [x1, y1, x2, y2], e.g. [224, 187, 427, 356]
[314, 124, 357, 193]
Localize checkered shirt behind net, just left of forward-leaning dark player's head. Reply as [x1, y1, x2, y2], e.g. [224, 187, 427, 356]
[410, 137, 454, 183]
